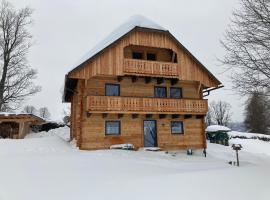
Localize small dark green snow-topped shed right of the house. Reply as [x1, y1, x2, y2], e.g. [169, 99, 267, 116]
[205, 125, 231, 146]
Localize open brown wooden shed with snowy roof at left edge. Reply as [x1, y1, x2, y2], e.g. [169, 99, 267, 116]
[0, 112, 45, 139]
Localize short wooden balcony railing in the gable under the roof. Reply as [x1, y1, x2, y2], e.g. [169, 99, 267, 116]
[124, 58, 179, 78]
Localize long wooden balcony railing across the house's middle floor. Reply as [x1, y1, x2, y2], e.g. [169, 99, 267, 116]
[87, 96, 208, 115]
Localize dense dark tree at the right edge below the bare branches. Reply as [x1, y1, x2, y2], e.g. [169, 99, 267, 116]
[244, 92, 270, 134]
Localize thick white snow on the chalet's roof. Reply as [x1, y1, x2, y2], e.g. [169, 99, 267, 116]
[69, 15, 167, 72]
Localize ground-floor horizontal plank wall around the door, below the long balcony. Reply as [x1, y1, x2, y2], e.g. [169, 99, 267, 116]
[80, 114, 205, 150]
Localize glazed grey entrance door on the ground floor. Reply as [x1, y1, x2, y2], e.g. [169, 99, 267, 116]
[143, 120, 157, 147]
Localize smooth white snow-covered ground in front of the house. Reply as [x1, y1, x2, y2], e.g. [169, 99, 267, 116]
[0, 128, 270, 200]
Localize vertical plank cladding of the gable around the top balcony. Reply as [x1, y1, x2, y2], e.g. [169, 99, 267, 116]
[68, 30, 219, 87]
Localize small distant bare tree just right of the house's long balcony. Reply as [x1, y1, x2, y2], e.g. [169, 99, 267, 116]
[209, 101, 231, 126]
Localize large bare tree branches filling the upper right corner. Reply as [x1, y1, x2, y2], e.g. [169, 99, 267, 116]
[221, 0, 270, 94]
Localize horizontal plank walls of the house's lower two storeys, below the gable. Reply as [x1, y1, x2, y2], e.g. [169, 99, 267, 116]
[68, 77, 206, 149]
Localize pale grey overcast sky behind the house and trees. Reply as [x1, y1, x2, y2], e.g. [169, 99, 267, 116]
[10, 0, 244, 121]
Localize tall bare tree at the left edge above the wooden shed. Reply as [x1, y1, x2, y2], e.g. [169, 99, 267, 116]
[0, 1, 40, 111]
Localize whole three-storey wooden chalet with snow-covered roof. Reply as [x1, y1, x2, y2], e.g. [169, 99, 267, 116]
[63, 17, 221, 149]
